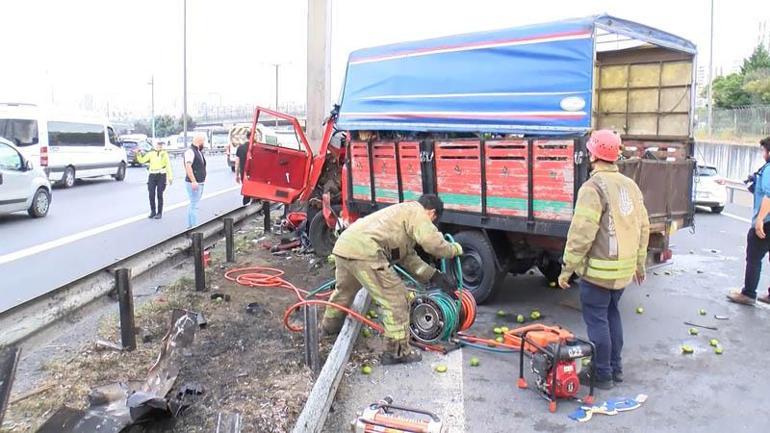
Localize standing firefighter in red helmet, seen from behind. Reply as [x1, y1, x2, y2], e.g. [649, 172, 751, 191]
[559, 130, 650, 389]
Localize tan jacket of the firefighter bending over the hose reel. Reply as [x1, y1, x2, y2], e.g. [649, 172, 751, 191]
[332, 201, 457, 281]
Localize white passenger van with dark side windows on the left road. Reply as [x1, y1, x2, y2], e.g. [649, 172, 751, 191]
[0, 103, 128, 188]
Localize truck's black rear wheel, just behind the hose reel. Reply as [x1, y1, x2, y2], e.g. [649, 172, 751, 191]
[455, 231, 498, 304]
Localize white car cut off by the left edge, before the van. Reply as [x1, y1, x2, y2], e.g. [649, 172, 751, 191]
[0, 138, 51, 218]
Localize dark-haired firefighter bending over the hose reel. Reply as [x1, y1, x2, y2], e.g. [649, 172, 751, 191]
[321, 194, 463, 364]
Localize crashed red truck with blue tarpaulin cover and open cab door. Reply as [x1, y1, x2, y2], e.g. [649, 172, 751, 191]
[242, 15, 697, 302]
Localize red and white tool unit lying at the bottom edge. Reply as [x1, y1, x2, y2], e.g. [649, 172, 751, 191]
[352, 396, 445, 433]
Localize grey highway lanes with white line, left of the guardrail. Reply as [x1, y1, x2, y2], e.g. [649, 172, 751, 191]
[0, 155, 241, 312]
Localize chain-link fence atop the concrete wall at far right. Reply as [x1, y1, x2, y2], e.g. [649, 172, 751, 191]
[695, 105, 770, 141]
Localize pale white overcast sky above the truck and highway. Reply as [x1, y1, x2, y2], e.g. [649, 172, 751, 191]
[0, 0, 770, 117]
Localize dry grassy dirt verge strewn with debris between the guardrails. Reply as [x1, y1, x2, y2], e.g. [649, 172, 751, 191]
[0, 213, 333, 433]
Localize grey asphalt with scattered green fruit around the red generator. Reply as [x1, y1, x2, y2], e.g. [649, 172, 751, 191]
[324, 206, 770, 433]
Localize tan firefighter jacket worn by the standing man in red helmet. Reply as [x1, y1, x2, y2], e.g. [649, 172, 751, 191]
[562, 162, 650, 289]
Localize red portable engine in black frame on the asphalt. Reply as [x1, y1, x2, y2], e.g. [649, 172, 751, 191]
[506, 325, 596, 412]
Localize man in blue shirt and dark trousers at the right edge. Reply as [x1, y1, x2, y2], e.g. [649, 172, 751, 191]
[727, 137, 770, 305]
